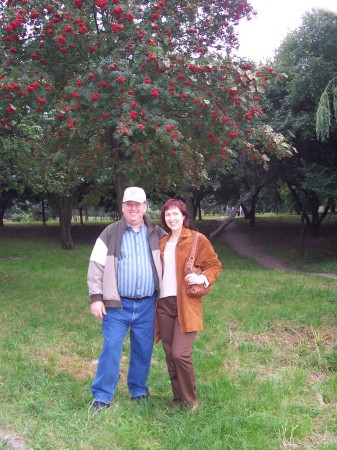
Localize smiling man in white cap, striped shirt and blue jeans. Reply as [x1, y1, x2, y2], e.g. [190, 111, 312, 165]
[88, 187, 166, 412]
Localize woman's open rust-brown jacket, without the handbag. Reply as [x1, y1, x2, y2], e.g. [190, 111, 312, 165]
[156, 227, 222, 342]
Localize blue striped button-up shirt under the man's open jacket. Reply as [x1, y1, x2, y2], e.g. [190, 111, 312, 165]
[117, 222, 154, 298]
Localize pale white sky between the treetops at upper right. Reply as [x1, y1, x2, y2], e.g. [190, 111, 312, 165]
[237, 0, 337, 62]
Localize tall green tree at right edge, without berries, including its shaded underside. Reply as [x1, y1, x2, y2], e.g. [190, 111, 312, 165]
[267, 10, 337, 236]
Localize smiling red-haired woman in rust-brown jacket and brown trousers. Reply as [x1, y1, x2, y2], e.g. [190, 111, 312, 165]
[157, 199, 221, 409]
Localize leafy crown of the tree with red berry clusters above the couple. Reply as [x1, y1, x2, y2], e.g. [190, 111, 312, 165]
[0, 0, 292, 248]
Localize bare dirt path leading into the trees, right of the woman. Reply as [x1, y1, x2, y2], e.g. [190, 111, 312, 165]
[220, 220, 337, 279]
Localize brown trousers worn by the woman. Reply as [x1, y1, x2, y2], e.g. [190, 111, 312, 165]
[157, 297, 198, 408]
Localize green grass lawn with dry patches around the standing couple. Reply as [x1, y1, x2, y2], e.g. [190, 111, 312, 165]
[0, 217, 337, 450]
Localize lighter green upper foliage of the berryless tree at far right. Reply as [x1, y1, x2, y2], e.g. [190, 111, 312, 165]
[274, 10, 337, 135]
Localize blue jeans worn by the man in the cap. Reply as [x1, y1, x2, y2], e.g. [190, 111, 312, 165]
[91, 296, 155, 403]
